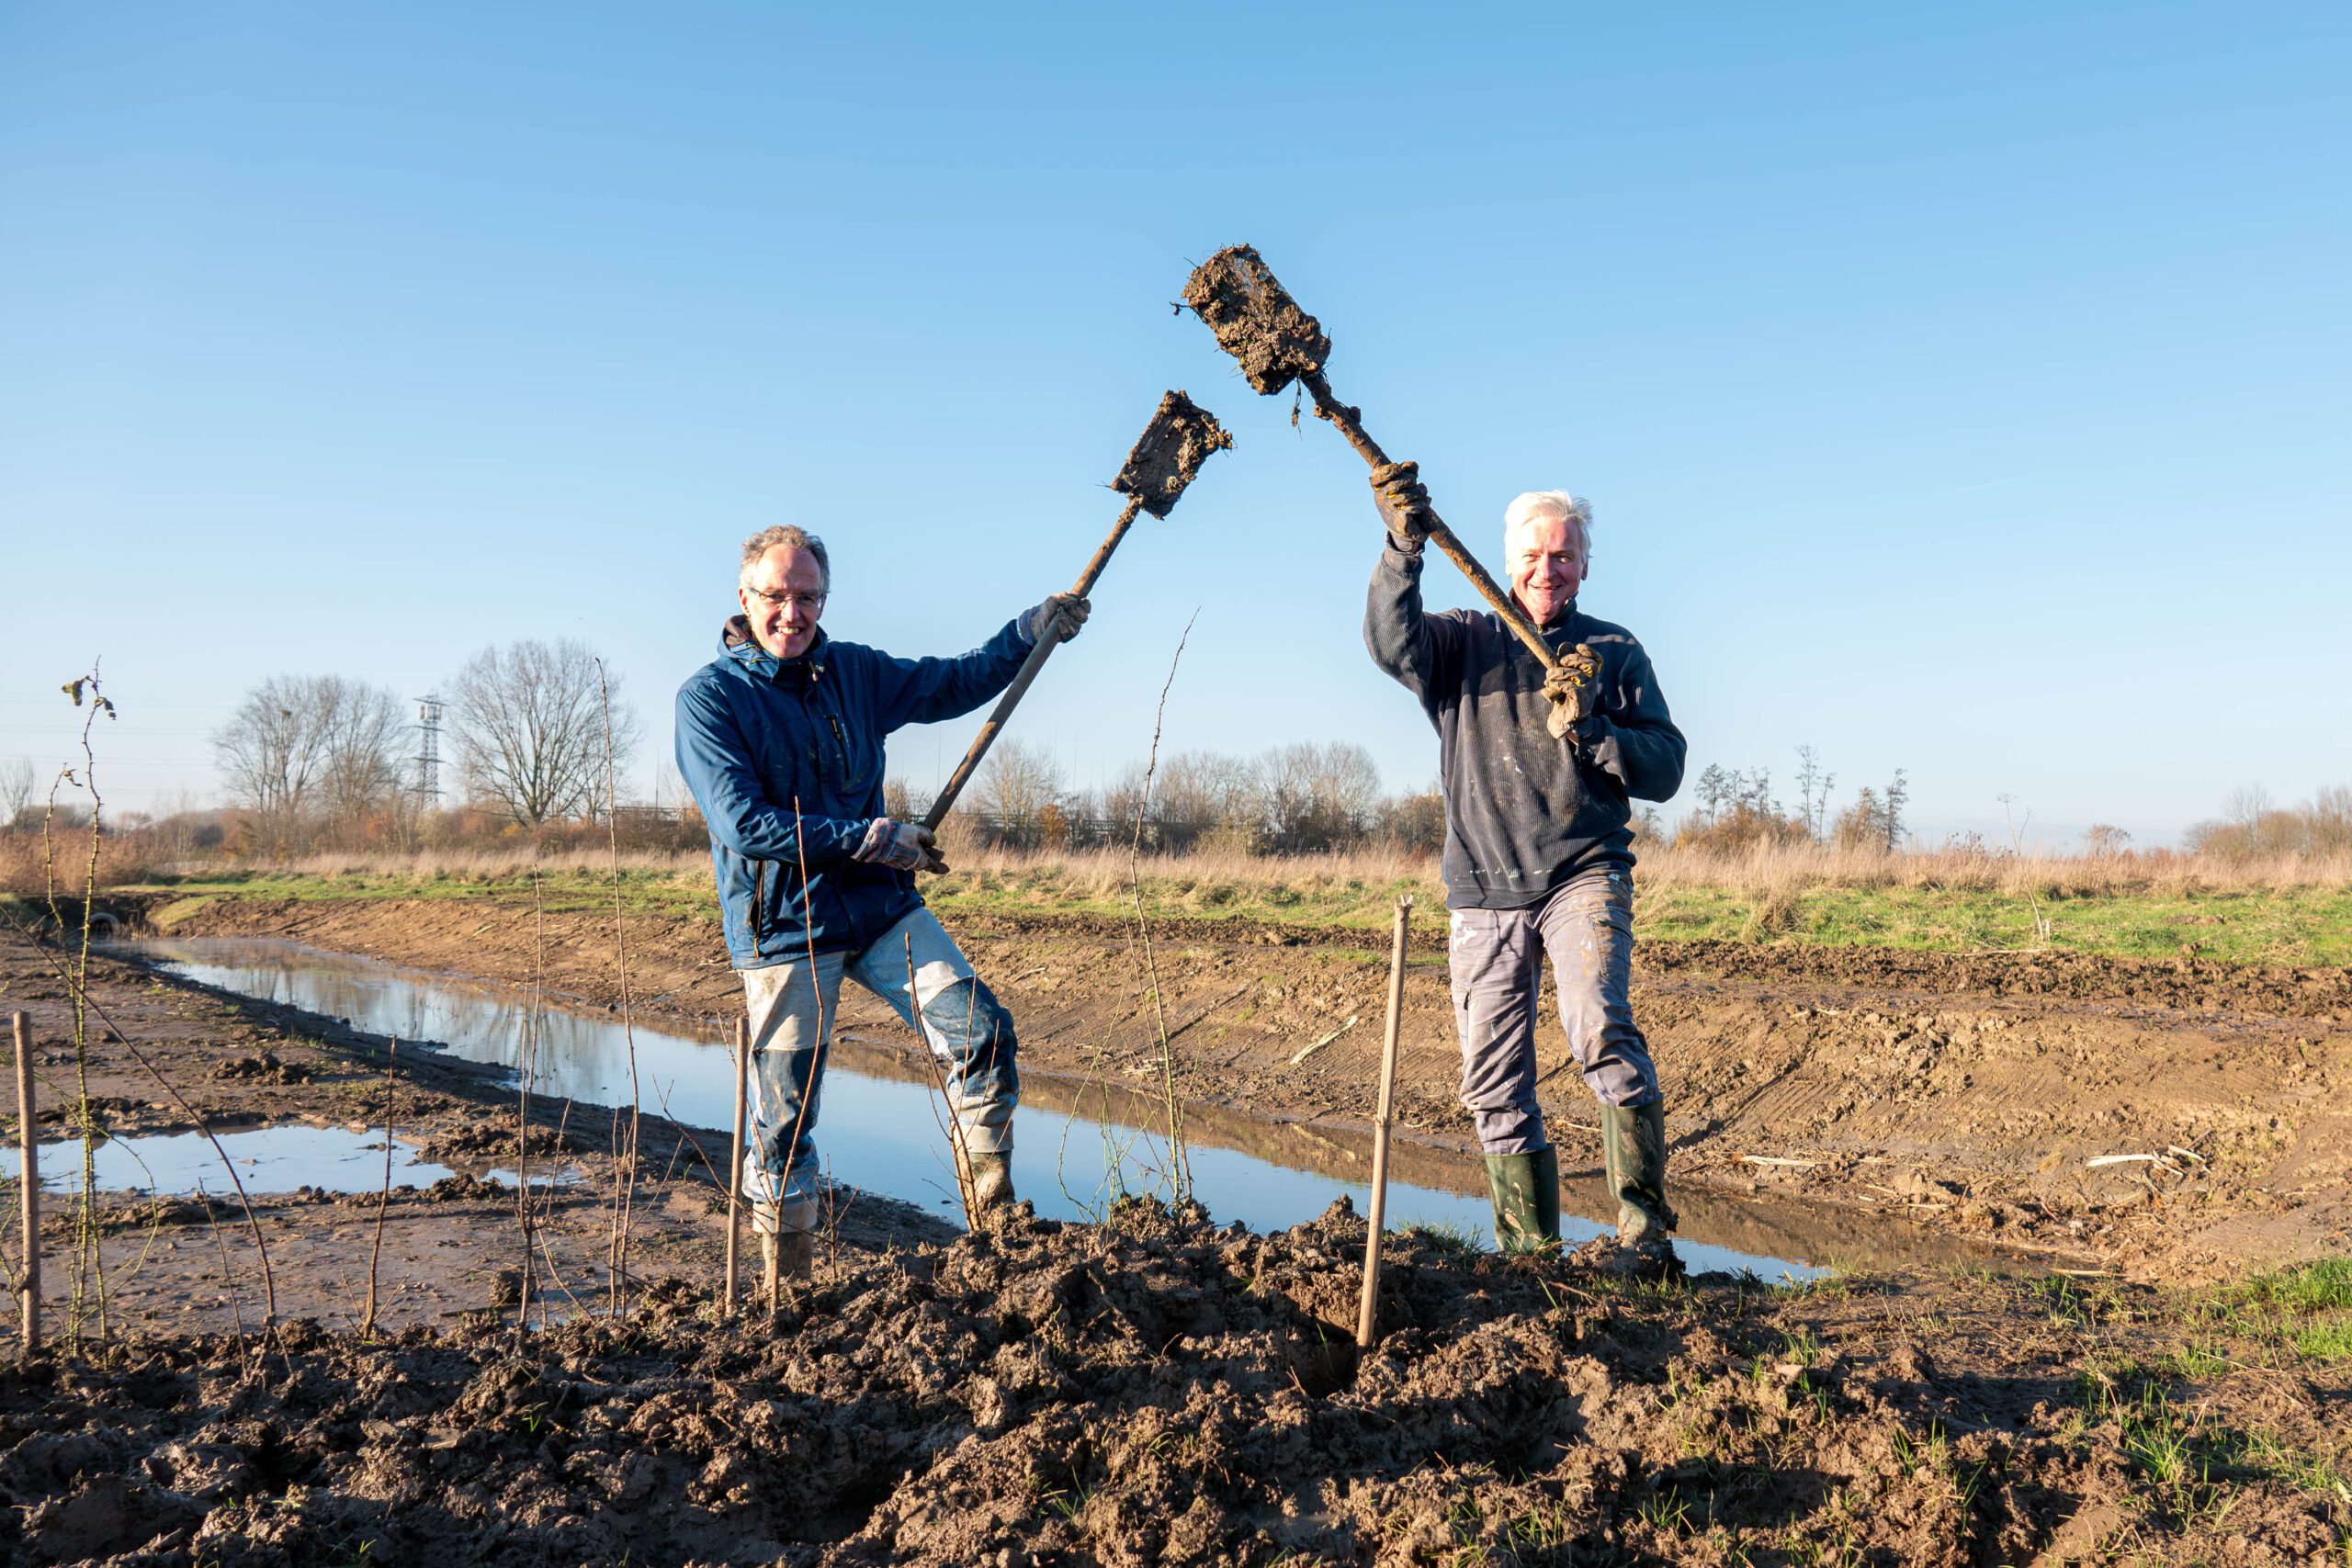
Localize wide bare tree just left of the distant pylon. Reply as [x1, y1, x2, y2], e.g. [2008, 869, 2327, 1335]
[211, 674, 402, 825]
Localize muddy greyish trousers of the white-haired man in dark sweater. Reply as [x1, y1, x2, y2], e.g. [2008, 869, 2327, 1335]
[1446, 865, 1658, 1155]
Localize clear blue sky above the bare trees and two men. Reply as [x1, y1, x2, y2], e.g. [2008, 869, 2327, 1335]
[0, 3, 2352, 841]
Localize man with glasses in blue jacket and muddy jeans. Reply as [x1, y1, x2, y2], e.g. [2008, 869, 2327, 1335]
[677, 526, 1089, 1274]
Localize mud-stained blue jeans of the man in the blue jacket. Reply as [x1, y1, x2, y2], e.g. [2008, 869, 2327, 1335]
[739, 909, 1021, 1229]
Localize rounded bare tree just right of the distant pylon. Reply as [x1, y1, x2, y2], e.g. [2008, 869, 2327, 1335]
[449, 637, 644, 825]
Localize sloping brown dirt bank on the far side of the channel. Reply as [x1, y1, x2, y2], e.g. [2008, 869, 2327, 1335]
[152, 898, 2352, 1277]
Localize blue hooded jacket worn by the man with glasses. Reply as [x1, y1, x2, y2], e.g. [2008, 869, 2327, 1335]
[677, 616, 1030, 968]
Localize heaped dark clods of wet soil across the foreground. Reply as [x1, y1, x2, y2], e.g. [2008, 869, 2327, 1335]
[0, 1203, 2352, 1568]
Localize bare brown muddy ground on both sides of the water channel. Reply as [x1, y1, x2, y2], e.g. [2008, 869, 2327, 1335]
[0, 905, 2352, 1563]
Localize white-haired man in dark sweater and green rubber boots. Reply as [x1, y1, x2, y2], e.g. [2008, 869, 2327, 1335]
[1364, 463, 1684, 1274]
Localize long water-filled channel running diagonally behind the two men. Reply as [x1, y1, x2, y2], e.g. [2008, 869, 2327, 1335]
[120, 938, 2013, 1279]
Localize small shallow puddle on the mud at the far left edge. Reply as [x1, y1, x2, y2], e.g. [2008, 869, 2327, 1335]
[0, 1126, 457, 1197]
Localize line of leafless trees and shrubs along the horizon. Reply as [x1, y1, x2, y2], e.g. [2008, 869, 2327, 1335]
[32, 637, 2352, 861]
